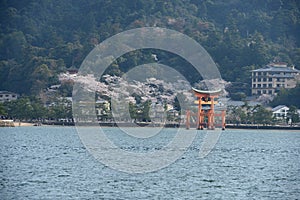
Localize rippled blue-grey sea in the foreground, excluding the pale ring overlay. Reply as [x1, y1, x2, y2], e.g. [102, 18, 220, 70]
[0, 127, 300, 200]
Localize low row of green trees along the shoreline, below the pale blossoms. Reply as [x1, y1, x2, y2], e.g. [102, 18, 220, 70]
[0, 96, 300, 125]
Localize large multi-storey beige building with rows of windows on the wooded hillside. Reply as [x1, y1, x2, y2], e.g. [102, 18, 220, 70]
[251, 63, 300, 95]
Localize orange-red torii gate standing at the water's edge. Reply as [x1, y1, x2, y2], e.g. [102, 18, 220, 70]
[186, 88, 226, 130]
